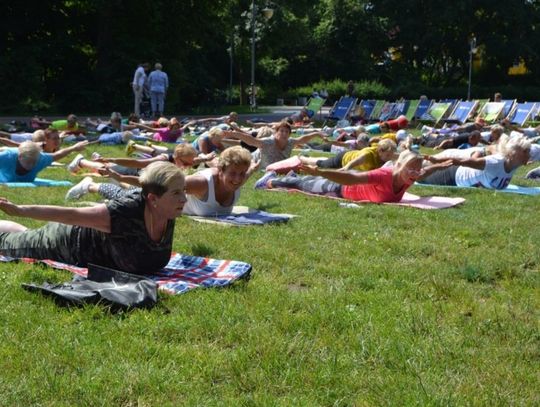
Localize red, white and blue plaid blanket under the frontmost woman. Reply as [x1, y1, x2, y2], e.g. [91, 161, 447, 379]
[0, 254, 251, 294]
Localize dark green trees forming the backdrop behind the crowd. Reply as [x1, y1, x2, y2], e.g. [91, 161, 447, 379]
[0, 0, 540, 112]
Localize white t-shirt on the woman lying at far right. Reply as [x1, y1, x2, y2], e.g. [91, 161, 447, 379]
[456, 154, 514, 189]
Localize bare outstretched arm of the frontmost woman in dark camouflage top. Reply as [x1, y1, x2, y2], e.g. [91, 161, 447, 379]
[0, 198, 111, 233]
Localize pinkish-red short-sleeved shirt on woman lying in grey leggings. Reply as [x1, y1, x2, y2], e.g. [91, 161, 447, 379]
[341, 167, 412, 202]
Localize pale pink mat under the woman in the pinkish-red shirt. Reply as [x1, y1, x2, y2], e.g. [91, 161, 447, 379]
[267, 188, 465, 209]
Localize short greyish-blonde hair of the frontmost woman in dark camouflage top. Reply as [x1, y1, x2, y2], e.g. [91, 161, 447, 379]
[139, 161, 185, 198]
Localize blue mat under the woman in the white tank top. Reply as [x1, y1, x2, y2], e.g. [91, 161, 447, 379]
[189, 206, 295, 226]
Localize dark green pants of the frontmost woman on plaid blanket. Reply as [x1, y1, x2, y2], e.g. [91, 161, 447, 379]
[0, 222, 80, 265]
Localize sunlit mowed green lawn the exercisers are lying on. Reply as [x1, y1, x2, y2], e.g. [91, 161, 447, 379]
[0, 142, 540, 406]
